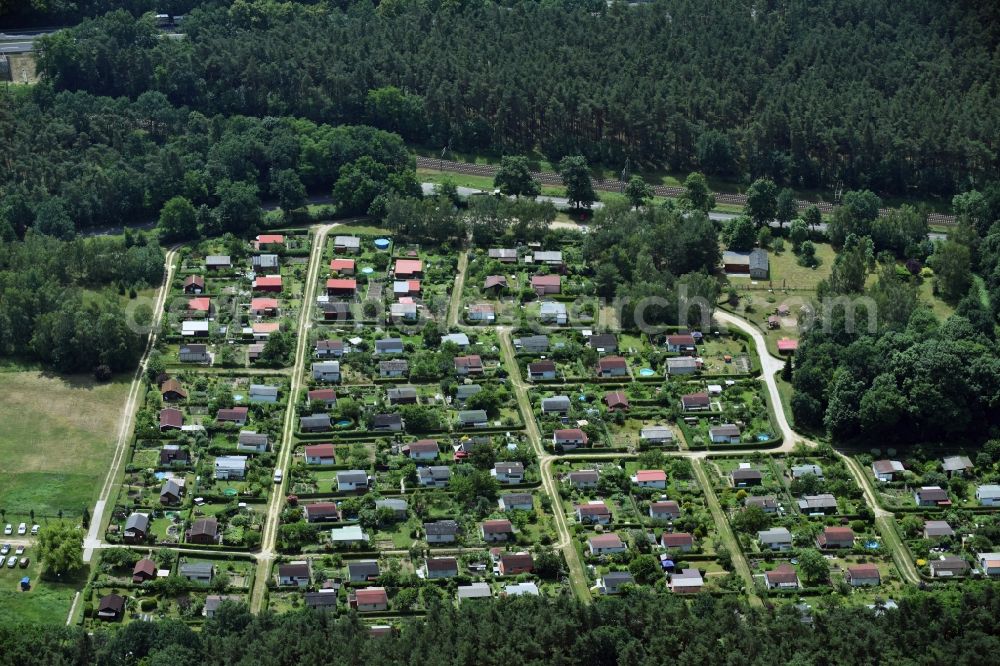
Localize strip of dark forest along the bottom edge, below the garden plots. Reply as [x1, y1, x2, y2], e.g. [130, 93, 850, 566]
[0, 582, 1000, 666]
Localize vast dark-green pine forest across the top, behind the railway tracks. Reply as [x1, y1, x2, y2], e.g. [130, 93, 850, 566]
[31, 0, 1000, 195]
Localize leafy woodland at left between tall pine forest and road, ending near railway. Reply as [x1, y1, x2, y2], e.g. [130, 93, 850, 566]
[0, 88, 419, 239]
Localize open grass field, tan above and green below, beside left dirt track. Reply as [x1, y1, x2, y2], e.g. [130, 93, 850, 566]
[0, 371, 129, 522]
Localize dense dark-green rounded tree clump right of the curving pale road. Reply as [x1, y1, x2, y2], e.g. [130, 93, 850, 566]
[792, 298, 1000, 445]
